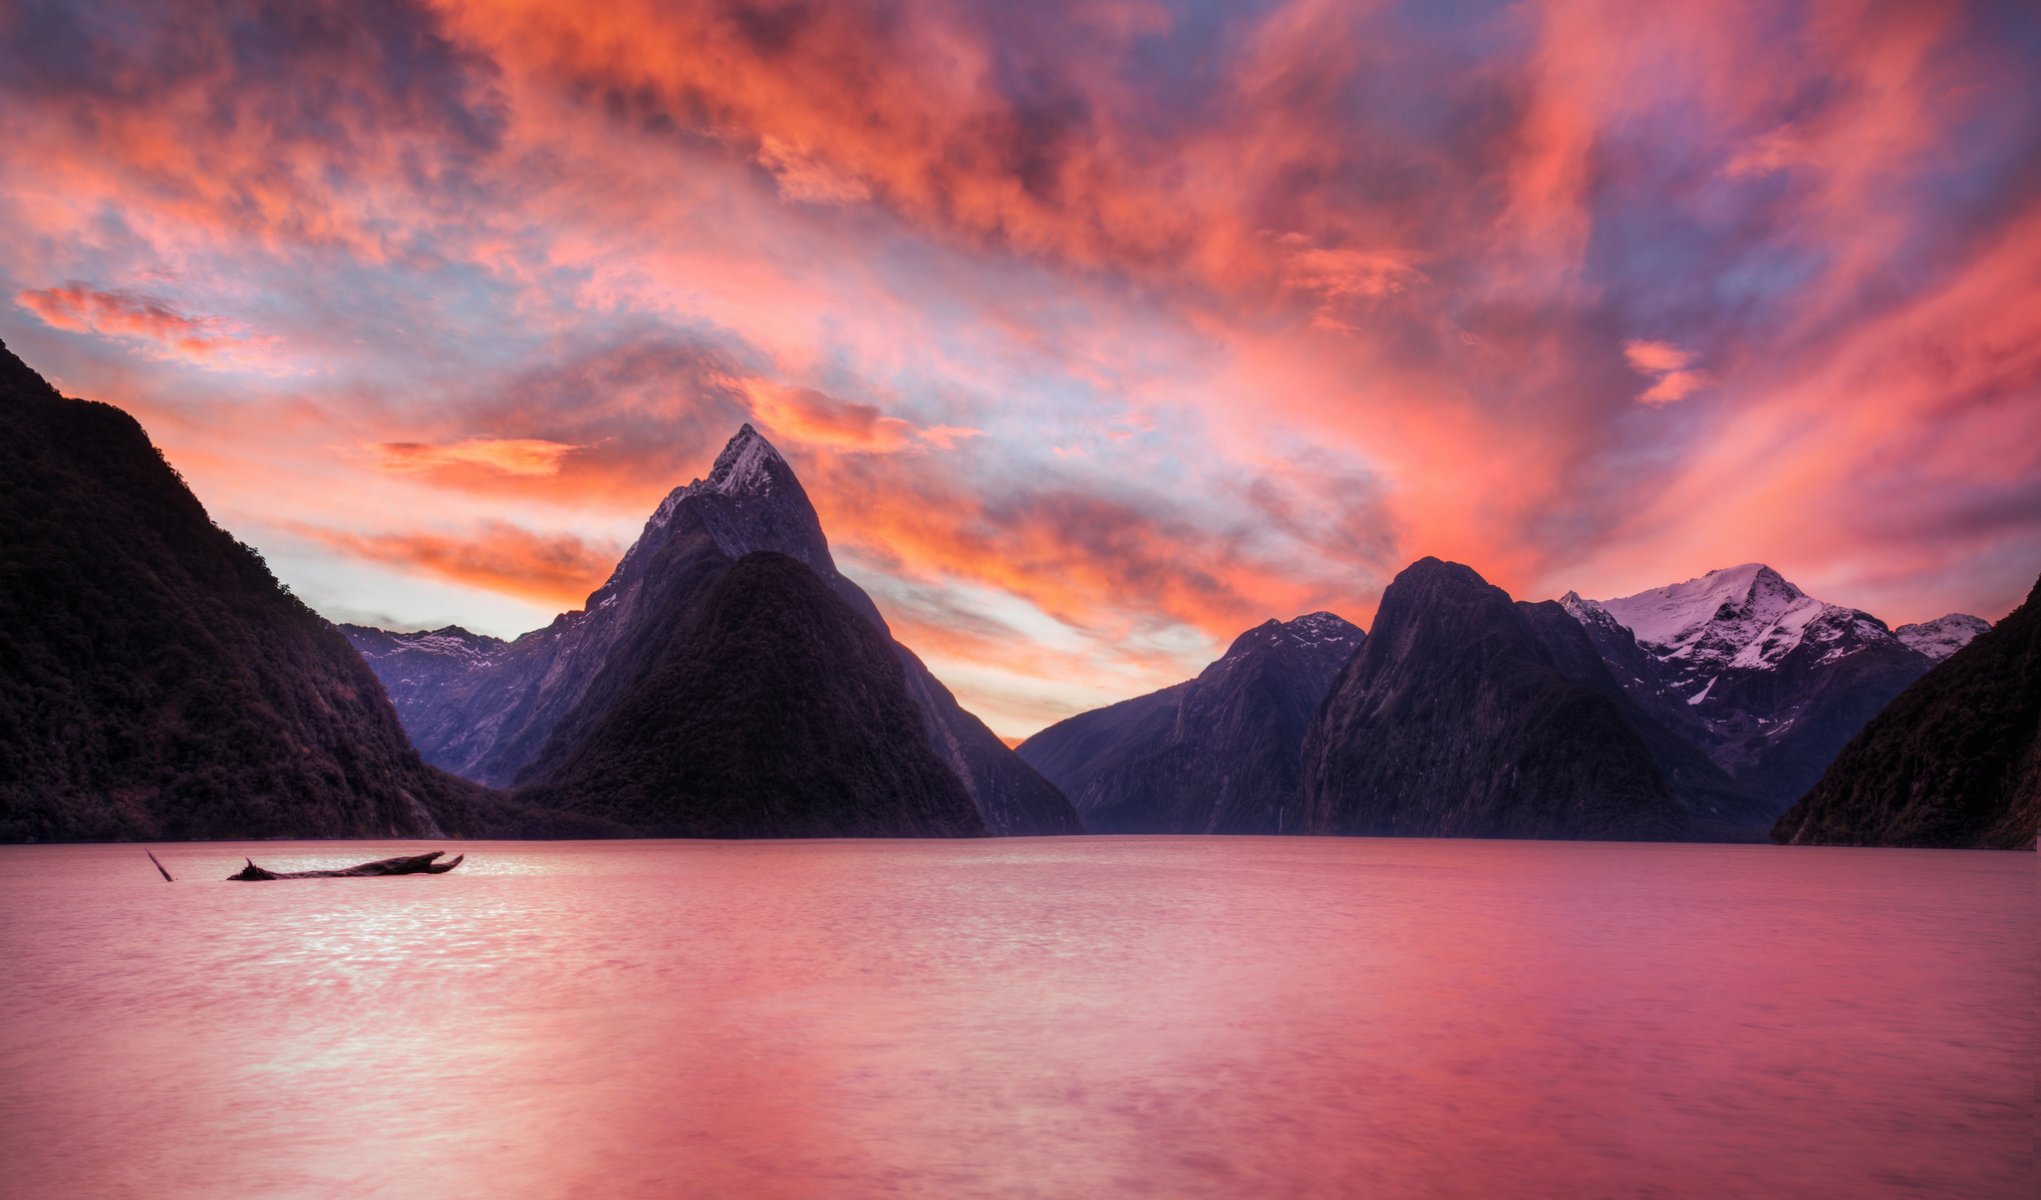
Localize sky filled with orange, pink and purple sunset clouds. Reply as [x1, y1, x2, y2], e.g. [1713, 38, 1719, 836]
[0, 0, 2041, 737]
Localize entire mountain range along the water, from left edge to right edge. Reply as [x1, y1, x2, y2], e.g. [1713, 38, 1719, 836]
[0, 336, 2041, 847]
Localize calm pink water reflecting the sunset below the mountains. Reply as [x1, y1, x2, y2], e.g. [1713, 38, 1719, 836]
[0, 839, 2037, 1198]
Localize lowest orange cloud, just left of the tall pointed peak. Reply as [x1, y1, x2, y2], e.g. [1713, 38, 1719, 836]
[292, 522, 623, 608]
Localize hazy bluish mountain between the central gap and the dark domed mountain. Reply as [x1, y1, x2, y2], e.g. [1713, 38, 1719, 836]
[1021, 612, 1367, 833]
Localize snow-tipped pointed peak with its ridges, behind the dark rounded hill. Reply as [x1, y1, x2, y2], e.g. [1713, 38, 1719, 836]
[349, 424, 1080, 835]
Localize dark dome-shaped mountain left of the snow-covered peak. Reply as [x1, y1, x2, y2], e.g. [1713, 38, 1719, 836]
[1304, 557, 1690, 839]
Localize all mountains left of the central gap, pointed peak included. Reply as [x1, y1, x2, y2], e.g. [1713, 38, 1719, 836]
[0, 349, 1020, 841]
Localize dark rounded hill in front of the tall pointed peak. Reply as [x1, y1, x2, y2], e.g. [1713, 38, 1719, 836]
[522, 542, 986, 837]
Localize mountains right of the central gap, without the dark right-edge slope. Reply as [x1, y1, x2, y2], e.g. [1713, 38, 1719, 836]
[1021, 559, 1990, 841]
